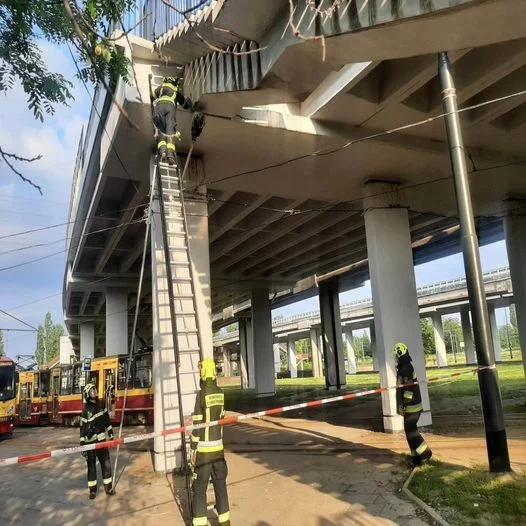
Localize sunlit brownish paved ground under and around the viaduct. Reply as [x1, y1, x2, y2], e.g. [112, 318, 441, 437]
[0, 405, 526, 526]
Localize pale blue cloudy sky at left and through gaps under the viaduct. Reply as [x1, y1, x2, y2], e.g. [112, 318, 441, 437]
[0, 43, 508, 364]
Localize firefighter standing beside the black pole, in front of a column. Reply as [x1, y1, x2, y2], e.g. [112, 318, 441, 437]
[393, 343, 432, 466]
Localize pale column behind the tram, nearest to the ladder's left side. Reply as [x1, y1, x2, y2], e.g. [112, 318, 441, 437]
[106, 289, 128, 356]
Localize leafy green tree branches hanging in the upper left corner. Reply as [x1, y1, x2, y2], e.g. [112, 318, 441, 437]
[0, 0, 135, 193]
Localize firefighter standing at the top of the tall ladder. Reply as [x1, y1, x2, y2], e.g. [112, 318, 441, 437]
[150, 77, 192, 165]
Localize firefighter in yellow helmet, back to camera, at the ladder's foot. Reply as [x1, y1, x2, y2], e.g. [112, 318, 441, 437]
[191, 358, 230, 526]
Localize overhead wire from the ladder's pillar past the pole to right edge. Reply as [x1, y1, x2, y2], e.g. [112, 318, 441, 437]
[191, 90, 526, 190]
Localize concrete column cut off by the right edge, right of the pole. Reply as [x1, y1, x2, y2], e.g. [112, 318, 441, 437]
[504, 215, 526, 374]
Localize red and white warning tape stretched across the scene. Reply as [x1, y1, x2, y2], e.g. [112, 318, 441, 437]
[0, 367, 480, 467]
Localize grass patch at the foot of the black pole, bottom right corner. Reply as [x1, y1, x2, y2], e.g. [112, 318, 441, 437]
[409, 461, 526, 526]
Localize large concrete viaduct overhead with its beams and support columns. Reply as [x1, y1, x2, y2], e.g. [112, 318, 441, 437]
[63, 0, 526, 470]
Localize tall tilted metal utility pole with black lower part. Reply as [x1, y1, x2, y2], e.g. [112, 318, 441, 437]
[438, 53, 511, 472]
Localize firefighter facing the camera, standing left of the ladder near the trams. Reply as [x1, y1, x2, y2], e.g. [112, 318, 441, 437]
[80, 383, 115, 499]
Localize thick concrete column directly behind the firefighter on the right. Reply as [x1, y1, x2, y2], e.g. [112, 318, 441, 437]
[364, 190, 431, 432]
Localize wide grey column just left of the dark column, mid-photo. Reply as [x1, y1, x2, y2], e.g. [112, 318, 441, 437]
[252, 287, 276, 397]
